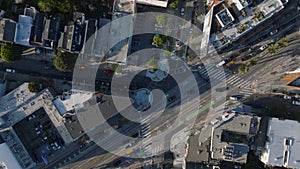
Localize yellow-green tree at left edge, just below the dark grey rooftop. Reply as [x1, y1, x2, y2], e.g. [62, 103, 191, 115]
[0, 43, 22, 62]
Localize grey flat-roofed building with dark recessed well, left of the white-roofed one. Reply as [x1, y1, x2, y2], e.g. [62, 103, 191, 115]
[210, 113, 260, 164]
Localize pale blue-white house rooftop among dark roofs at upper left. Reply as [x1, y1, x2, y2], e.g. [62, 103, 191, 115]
[15, 15, 33, 46]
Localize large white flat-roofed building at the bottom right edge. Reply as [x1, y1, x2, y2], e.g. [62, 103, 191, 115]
[260, 118, 300, 168]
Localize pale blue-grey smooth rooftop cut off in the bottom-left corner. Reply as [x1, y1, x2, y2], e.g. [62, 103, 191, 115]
[0, 143, 22, 169]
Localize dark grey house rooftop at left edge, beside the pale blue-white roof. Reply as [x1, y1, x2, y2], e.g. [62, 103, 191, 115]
[0, 18, 17, 42]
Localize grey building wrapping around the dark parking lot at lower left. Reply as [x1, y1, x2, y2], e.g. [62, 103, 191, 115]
[0, 83, 74, 169]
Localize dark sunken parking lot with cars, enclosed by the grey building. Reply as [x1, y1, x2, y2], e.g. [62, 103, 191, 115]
[13, 108, 64, 163]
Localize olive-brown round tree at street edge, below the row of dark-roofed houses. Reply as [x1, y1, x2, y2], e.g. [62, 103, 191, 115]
[53, 52, 77, 72]
